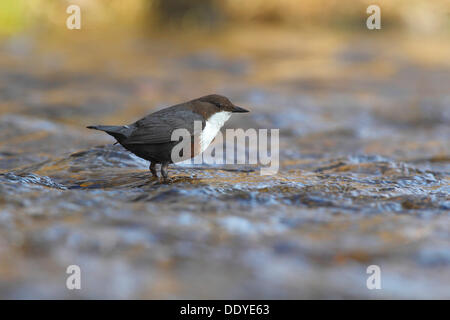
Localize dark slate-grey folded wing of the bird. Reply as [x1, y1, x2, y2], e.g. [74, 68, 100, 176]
[121, 105, 205, 144]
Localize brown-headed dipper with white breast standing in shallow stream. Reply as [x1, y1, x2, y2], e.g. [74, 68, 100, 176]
[87, 94, 249, 182]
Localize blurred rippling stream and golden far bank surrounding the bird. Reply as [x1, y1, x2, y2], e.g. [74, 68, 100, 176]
[0, 0, 450, 299]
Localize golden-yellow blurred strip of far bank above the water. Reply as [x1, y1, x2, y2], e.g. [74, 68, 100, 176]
[0, 0, 450, 35]
